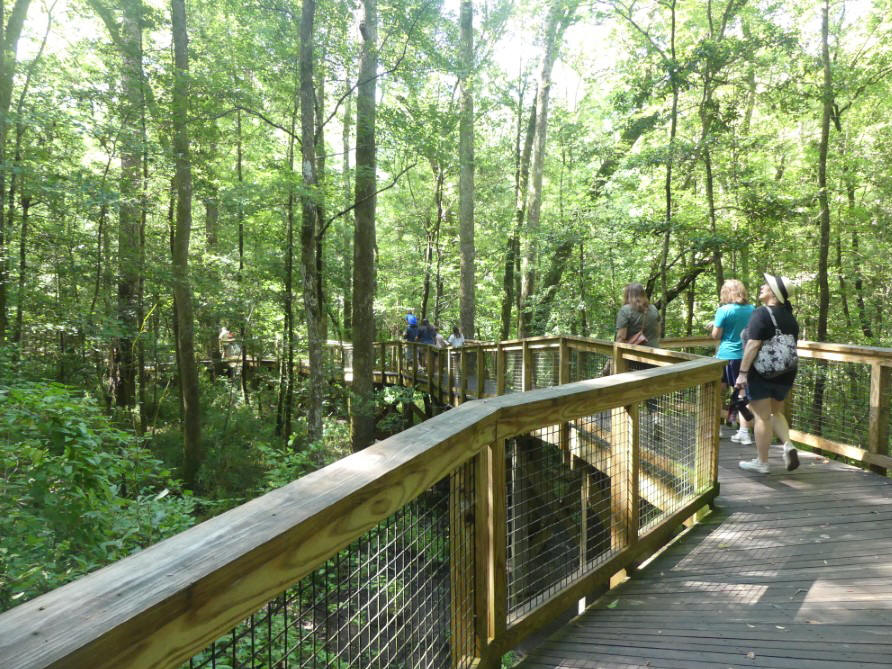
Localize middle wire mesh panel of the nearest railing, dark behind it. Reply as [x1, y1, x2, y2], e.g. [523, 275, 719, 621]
[506, 416, 629, 621]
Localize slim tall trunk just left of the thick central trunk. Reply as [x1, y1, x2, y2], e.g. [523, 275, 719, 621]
[300, 0, 323, 442]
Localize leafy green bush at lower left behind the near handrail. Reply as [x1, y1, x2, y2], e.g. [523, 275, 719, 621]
[0, 382, 195, 610]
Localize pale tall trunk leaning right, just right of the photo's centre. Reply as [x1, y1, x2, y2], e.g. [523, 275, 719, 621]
[518, 0, 576, 337]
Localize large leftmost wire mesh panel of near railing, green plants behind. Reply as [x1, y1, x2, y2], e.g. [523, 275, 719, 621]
[184, 460, 476, 669]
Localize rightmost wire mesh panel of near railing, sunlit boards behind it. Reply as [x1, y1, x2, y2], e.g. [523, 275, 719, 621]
[638, 385, 716, 533]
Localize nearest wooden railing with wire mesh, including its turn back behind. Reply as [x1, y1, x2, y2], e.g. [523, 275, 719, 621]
[0, 338, 721, 669]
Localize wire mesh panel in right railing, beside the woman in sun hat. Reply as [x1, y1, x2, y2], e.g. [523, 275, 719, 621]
[790, 358, 871, 448]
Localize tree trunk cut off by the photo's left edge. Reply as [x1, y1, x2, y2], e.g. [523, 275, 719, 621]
[0, 0, 31, 342]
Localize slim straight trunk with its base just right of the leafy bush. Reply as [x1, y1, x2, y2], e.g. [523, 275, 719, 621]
[170, 0, 203, 487]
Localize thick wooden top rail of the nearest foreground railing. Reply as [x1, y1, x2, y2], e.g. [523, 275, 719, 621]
[0, 342, 720, 669]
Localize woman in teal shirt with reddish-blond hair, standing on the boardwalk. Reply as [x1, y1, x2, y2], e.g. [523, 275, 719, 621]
[711, 279, 755, 445]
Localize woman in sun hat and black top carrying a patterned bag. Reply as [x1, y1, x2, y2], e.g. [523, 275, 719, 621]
[734, 273, 799, 474]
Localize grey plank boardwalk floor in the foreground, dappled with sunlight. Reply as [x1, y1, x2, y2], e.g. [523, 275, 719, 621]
[520, 440, 892, 669]
